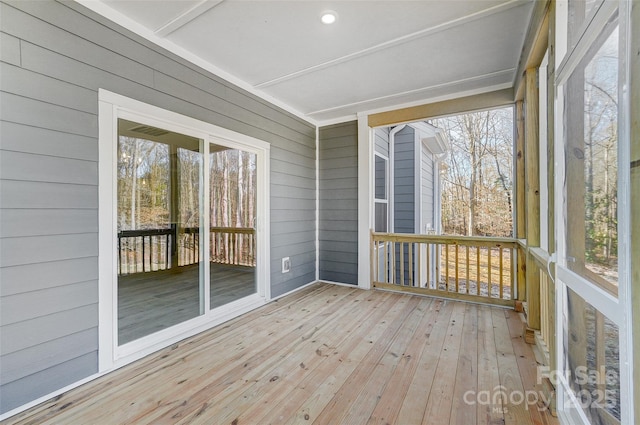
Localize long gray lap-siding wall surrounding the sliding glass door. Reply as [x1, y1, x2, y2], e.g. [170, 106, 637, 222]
[0, 1, 316, 412]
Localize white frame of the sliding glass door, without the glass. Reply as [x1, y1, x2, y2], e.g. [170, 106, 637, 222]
[98, 89, 271, 373]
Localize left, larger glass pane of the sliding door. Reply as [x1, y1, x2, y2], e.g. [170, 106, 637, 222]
[117, 119, 204, 345]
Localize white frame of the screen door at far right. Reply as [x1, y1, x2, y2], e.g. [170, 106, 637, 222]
[554, 0, 634, 424]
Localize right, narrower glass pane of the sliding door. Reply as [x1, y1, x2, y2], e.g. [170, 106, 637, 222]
[209, 144, 257, 309]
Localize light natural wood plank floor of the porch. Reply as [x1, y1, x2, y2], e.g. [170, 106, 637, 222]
[3, 284, 557, 425]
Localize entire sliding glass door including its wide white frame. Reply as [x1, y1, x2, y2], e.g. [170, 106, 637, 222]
[98, 89, 270, 372]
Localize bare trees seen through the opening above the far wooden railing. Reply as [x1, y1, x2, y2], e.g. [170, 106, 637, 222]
[432, 108, 513, 236]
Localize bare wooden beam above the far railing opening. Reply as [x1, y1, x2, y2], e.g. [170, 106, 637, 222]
[369, 88, 513, 127]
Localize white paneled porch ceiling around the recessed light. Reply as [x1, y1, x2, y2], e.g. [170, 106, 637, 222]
[82, 0, 534, 124]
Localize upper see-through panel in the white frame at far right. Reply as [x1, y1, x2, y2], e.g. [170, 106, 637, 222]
[565, 25, 618, 295]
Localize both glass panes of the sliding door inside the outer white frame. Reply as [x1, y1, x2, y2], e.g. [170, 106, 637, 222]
[116, 118, 258, 345]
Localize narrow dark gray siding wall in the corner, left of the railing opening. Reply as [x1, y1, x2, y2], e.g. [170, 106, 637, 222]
[318, 121, 358, 285]
